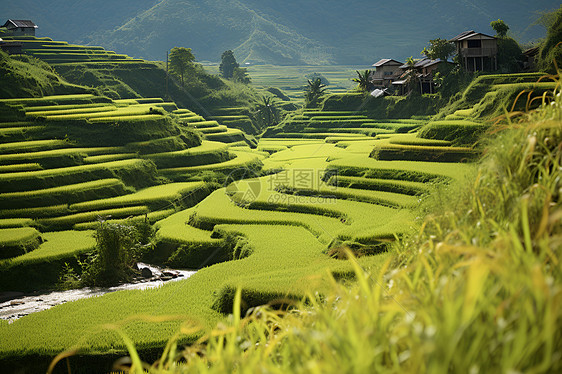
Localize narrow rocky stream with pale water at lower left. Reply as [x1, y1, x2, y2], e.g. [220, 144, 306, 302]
[0, 262, 196, 322]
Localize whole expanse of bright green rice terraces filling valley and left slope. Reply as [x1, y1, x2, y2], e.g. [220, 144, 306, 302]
[0, 64, 530, 372]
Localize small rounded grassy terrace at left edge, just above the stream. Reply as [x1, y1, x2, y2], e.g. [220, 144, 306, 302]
[0, 227, 41, 259]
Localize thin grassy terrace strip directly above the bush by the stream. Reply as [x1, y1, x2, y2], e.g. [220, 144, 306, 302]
[37, 205, 150, 231]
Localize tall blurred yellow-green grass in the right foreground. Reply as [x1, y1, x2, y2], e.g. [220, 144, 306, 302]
[53, 82, 562, 373]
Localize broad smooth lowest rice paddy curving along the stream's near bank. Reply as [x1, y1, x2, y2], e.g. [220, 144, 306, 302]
[0, 225, 372, 358]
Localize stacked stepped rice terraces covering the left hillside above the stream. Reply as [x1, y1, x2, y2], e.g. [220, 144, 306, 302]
[0, 94, 264, 290]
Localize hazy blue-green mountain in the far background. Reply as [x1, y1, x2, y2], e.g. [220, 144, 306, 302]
[0, 0, 560, 65]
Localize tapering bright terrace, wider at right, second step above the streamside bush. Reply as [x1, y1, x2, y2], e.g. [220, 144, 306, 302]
[69, 182, 208, 212]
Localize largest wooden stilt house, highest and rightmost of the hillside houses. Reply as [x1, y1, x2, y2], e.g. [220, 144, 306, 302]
[449, 30, 498, 71]
